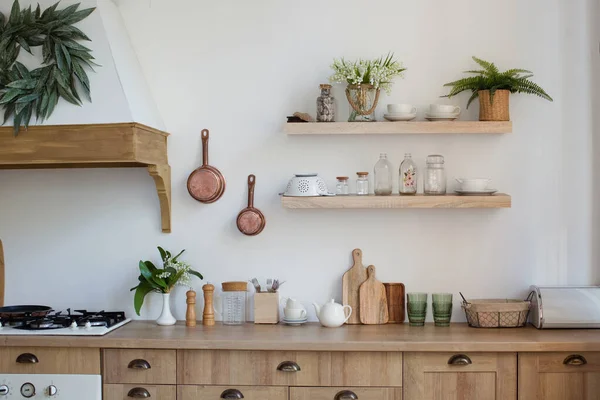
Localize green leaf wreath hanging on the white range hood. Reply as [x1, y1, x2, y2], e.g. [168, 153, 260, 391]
[0, 0, 98, 135]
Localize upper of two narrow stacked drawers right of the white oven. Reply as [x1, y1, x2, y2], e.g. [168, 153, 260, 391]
[104, 349, 177, 385]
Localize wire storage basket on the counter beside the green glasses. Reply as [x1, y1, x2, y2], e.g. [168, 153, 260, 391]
[462, 297, 531, 328]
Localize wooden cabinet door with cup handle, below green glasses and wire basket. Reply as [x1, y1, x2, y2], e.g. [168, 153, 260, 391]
[404, 353, 517, 400]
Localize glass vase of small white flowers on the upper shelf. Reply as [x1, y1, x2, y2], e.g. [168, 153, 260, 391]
[329, 53, 406, 122]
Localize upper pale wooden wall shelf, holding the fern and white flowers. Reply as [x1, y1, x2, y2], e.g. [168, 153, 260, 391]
[283, 121, 512, 135]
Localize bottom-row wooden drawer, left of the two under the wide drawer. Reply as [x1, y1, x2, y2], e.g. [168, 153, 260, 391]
[177, 385, 288, 400]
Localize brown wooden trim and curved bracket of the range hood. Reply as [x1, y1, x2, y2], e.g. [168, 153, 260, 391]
[0, 122, 171, 233]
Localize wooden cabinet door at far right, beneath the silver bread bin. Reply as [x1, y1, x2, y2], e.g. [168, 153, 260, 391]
[519, 352, 600, 400]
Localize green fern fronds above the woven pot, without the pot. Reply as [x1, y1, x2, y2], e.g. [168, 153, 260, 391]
[442, 57, 552, 108]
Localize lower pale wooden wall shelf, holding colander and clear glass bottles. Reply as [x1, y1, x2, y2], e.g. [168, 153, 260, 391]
[281, 193, 511, 209]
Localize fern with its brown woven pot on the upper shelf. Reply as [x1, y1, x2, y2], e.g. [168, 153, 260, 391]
[442, 57, 552, 121]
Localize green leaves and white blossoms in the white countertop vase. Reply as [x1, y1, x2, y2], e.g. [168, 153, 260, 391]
[131, 247, 204, 315]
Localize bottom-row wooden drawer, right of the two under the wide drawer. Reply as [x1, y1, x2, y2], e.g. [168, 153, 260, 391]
[292, 387, 402, 400]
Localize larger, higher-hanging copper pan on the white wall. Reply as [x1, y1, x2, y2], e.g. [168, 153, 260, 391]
[187, 129, 225, 204]
